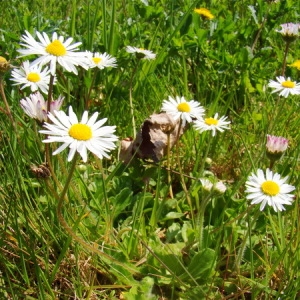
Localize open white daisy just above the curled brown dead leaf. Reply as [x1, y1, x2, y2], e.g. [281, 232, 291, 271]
[161, 96, 204, 127]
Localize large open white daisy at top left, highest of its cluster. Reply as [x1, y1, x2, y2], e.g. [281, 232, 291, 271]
[18, 31, 87, 75]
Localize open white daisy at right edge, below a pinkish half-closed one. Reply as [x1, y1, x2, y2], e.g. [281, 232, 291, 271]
[268, 76, 300, 98]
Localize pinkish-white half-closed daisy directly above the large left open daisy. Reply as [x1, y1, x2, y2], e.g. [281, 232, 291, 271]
[20, 92, 64, 123]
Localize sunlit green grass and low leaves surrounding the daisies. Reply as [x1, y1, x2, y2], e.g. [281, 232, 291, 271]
[0, 0, 300, 300]
